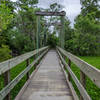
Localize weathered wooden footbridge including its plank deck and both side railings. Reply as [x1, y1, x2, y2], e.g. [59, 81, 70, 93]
[0, 46, 100, 100]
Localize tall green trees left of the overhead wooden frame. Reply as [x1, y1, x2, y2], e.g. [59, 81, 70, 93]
[0, 0, 39, 55]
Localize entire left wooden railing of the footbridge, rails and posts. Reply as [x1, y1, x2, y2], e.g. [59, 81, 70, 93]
[0, 46, 49, 100]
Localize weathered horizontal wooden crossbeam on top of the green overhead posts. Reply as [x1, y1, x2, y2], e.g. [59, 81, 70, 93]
[35, 11, 66, 16]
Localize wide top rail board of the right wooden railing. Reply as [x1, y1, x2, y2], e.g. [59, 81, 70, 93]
[58, 47, 100, 88]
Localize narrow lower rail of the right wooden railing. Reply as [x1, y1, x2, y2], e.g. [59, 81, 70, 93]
[59, 50, 91, 100]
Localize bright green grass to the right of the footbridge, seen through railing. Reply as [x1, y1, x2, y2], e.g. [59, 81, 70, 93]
[66, 56, 100, 100]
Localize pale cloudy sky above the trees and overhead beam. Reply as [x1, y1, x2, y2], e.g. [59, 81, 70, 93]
[12, 0, 81, 26]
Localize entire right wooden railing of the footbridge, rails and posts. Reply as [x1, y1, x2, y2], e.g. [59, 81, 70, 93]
[57, 47, 100, 100]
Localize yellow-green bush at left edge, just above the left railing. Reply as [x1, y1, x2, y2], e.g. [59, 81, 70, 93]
[0, 45, 11, 62]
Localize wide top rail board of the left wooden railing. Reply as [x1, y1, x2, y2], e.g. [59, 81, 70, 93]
[0, 46, 48, 75]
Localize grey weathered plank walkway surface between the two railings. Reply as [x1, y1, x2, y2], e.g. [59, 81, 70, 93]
[17, 50, 73, 100]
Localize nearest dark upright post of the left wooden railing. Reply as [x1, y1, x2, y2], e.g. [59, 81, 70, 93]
[4, 70, 11, 100]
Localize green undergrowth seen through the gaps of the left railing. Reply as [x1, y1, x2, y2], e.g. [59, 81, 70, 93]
[0, 58, 34, 100]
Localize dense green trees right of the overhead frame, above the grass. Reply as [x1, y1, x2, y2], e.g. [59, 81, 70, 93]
[65, 0, 100, 56]
